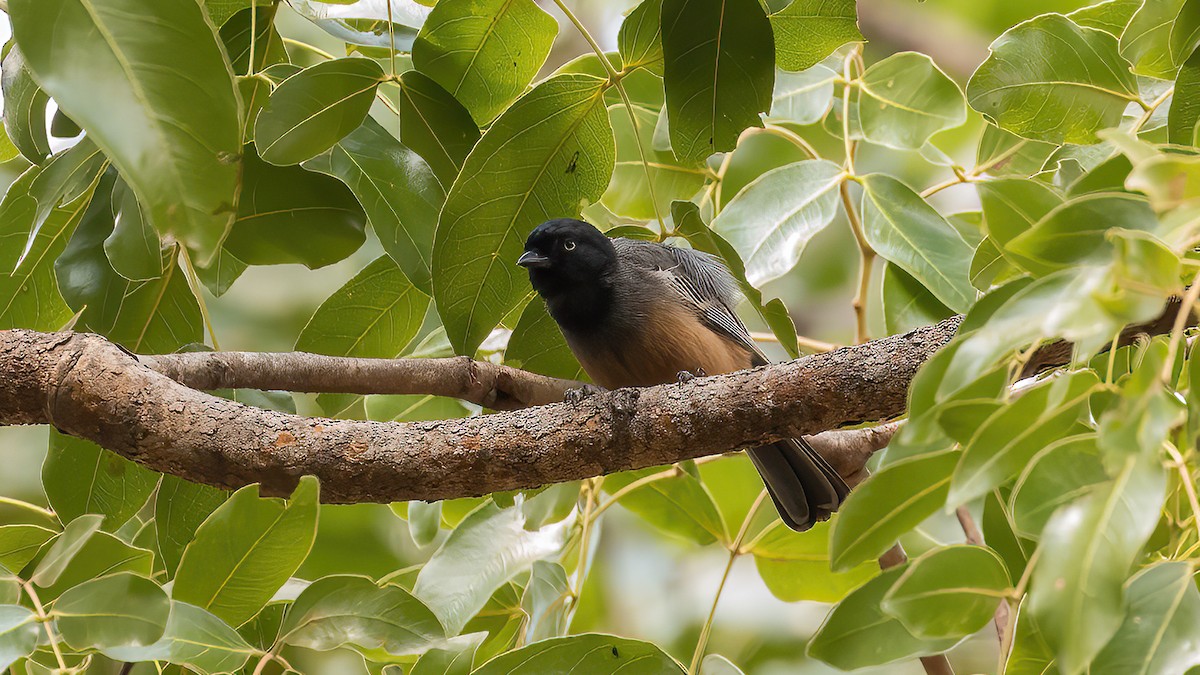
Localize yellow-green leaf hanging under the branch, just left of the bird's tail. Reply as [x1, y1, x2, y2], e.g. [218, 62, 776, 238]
[604, 466, 730, 545]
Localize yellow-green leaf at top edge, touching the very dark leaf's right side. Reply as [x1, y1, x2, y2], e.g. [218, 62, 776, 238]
[770, 0, 863, 71]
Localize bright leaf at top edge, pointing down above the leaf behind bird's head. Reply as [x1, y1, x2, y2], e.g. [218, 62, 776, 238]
[413, 0, 558, 125]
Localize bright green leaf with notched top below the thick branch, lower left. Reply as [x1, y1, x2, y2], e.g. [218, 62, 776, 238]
[172, 476, 318, 626]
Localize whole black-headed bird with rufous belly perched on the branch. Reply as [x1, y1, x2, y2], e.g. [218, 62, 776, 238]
[516, 219, 850, 532]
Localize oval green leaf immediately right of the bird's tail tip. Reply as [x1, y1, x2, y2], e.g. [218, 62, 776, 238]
[829, 450, 959, 572]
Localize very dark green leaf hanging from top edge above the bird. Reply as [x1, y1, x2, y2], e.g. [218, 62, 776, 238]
[662, 0, 772, 160]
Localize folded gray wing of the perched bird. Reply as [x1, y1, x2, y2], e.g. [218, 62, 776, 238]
[613, 239, 767, 365]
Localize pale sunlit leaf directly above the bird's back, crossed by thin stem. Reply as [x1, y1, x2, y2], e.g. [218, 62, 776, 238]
[600, 106, 707, 220]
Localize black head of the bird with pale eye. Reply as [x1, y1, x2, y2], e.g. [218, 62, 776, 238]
[517, 219, 617, 327]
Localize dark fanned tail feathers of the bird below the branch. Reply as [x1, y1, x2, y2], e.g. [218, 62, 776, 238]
[748, 438, 850, 532]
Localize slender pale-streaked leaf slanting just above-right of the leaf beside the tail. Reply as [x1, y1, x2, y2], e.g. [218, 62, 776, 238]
[946, 370, 1099, 507]
